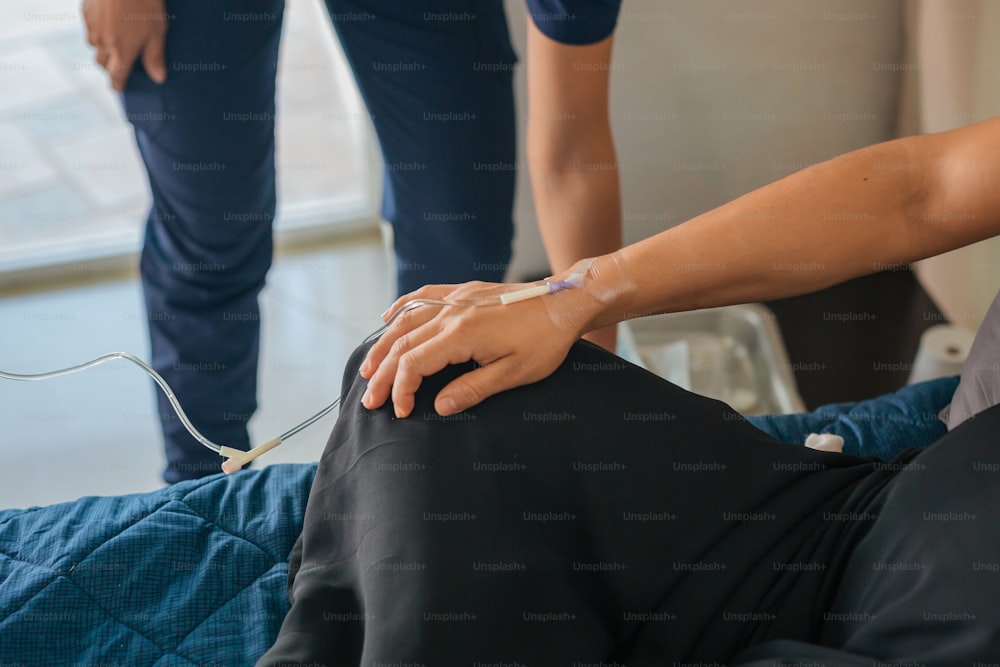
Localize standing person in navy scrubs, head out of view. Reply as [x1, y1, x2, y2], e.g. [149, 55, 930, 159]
[83, 0, 621, 482]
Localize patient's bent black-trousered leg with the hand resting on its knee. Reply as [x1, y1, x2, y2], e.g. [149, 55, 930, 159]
[260, 343, 908, 666]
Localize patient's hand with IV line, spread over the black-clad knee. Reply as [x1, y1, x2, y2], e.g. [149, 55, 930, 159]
[361, 282, 594, 417]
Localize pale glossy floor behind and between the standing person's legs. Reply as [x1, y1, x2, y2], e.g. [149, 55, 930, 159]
[0, 234, 395, 509]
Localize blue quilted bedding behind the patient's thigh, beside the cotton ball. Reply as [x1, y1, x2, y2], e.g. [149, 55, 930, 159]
[747, 376, 958, 460]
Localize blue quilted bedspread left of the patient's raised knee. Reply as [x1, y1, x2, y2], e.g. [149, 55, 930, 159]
[0, 465, 316, 667]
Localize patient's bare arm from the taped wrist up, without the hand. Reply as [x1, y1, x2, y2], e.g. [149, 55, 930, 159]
[592, 121, 1000, 326]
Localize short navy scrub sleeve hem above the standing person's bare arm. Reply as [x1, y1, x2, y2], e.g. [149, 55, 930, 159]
[528, 0, 622, 45]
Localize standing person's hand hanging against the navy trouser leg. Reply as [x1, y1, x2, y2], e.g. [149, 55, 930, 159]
[83, 0, 167, 92]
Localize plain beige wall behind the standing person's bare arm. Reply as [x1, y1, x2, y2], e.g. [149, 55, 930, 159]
[507, 0, 903, 278]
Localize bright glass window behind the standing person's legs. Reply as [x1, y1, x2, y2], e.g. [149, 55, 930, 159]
[0, 0, 379, 273]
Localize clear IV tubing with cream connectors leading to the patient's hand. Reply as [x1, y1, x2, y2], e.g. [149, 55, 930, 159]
[0, 271, 584, 474]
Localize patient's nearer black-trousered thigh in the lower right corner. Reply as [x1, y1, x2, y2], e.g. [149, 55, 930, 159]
[822, 407, 1000, 665]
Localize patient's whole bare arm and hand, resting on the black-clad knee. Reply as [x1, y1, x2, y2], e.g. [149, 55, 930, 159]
[361, 118, 1000, 417]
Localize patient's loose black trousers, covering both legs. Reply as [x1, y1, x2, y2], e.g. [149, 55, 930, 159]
[259, 343, 1000, 667]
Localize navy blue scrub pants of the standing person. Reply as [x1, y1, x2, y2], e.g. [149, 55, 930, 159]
[123, 0, 516, 482]
